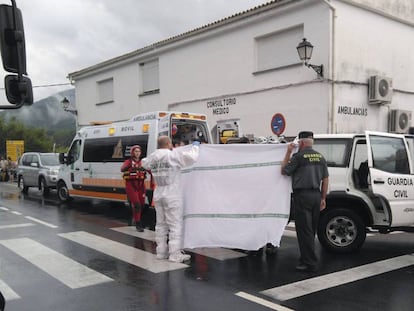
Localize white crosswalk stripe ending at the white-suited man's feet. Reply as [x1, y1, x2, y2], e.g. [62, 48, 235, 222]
[58, 231, 188, 273]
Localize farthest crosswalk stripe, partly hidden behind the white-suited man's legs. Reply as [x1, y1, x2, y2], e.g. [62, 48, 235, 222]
[111, 226, 247, 261]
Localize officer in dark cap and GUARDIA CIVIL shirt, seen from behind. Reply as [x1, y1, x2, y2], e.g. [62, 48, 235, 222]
[281, 131, 329, 272]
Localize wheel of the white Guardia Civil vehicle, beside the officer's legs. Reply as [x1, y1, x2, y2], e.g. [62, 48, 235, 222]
[318, 208, 367, 253]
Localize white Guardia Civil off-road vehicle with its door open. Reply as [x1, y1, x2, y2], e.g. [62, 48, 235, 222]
[314, 131, 414, 253]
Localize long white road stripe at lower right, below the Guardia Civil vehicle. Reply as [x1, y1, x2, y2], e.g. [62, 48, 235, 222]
[261, 254, 414, 301]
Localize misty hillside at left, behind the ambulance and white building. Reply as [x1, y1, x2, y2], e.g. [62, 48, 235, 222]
[0, 89, 76, 131]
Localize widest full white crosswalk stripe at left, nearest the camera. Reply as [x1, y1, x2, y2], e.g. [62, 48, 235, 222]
[0, 238, 113, 289]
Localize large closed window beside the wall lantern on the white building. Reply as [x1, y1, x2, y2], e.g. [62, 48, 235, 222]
[256, 25, 303, 71]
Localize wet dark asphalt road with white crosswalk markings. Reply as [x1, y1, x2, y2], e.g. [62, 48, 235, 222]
[0, 183, 414, 311]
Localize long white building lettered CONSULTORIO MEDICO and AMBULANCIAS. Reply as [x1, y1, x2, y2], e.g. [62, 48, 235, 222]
[68, 0, 414, 136]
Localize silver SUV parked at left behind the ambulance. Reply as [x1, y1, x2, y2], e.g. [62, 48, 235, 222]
[16, 152, 60, 196]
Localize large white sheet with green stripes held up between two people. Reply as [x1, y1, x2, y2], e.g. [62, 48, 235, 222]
[182, 144, 291, 250]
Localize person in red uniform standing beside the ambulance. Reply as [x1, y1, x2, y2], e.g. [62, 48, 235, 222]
[121, 145, 152, 232]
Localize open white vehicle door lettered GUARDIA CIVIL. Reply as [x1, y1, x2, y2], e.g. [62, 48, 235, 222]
[366, 131, 414, 227]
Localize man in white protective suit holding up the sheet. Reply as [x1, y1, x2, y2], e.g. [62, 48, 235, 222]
[142, 136, 200, 262]
